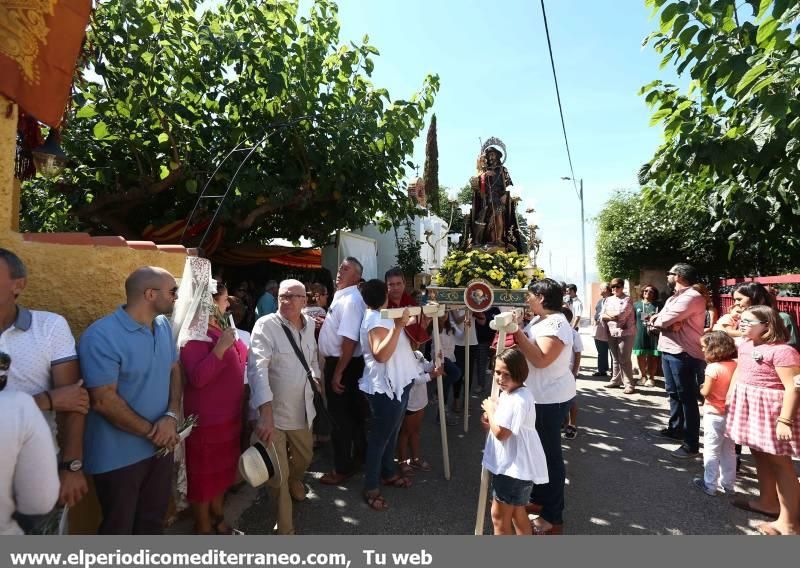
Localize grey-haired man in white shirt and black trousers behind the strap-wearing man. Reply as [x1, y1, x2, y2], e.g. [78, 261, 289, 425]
[319, 257, 366, 485]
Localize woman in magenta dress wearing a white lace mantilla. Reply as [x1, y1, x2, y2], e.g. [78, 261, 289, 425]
[181, 284, 247, 534]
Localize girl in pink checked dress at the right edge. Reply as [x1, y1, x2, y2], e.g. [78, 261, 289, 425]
[728, 306, 800, 535]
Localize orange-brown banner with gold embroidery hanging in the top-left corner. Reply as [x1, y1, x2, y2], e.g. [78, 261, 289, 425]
[0, 0, 92, 128]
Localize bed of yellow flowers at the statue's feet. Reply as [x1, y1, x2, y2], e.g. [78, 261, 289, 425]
[434, 250, 544, 290]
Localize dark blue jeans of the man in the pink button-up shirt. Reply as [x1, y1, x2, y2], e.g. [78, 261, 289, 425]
[661, 353, 705, 452]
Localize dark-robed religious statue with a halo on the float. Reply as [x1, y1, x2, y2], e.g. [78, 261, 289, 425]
[465, 137, 520, 250]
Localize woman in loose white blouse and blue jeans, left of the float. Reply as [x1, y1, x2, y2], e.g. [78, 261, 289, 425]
[358, 279, 418, 511]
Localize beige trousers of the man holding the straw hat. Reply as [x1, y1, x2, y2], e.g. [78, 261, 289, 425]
[270, 428, 314, 534]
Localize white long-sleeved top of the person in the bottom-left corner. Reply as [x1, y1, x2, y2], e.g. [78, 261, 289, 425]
[0, 388, 60, 535]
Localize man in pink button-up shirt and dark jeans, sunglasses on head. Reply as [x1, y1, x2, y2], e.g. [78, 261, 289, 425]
[650, 263, 706, 459]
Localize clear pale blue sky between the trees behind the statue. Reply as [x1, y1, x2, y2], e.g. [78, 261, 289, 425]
[326, 0, 675, 283]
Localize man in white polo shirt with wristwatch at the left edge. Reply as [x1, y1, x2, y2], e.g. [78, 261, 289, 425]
[0, 248, 89, 506]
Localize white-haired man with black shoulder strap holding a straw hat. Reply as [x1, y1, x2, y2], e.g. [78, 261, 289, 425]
[247, 280, 320, 534]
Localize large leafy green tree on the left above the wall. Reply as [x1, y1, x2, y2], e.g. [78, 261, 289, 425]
[23, 0, 438, 248]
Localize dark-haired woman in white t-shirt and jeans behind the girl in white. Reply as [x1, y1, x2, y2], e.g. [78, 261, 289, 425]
[514, 278, 576, 535]
